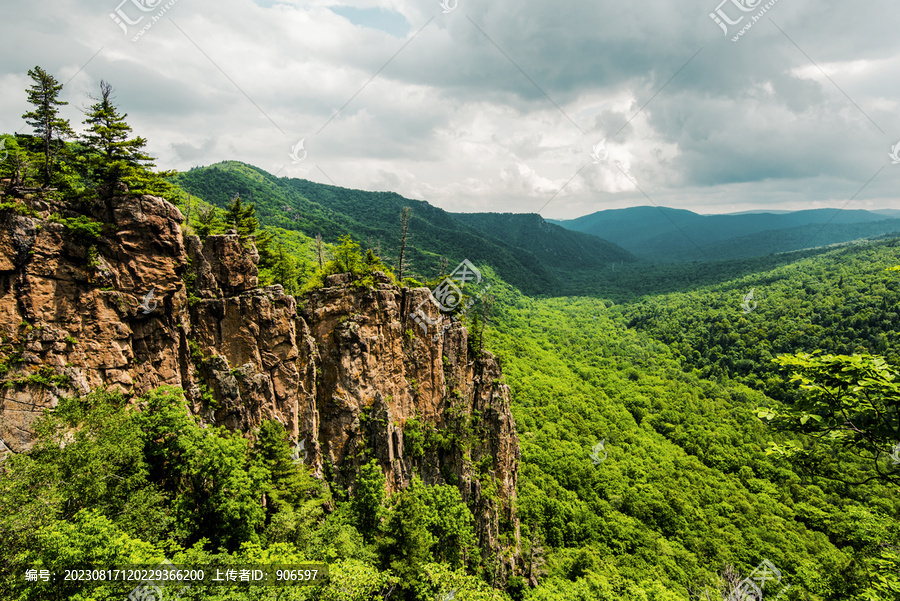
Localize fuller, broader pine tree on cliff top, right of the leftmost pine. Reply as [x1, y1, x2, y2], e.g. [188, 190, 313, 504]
[84, 81, 159, 194]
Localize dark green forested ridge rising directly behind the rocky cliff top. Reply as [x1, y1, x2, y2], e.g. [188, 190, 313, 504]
[175, 161, 633, 294]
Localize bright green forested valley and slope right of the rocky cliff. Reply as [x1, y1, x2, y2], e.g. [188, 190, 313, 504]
[488, 239, 900, 601]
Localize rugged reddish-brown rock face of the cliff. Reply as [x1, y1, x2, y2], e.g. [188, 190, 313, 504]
[0, 196, 519, 579]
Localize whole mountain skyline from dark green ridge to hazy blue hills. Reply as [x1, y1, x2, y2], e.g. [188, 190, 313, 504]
[175, 161, 900, 288]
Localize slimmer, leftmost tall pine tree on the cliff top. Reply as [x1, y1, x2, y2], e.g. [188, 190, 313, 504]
[22, 67, 75, 186]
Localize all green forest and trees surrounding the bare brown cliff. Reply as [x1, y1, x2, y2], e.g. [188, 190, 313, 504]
[0, 68, 900, 601]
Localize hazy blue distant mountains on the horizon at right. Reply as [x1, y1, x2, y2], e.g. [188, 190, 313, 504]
[548, 206, 900, 262]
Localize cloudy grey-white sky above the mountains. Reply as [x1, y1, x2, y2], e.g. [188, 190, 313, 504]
[0, 0, 900, 219]
